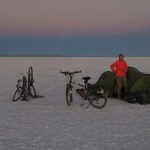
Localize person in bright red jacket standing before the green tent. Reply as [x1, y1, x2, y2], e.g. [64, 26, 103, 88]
[110, 54, 128, 99]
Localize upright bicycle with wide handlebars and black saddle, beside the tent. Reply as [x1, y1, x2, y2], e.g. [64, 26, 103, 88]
[60, 70, 107, 109]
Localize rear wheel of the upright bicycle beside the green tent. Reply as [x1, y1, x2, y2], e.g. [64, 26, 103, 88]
[88, 93, 107, 109]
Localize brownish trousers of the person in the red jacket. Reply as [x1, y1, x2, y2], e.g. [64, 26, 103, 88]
[116, 76, 127, 99]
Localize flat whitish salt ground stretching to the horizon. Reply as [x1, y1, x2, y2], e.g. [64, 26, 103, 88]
[0, 57, 150, 150]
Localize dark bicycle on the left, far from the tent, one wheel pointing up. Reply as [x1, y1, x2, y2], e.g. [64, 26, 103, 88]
[13, 66, 36, 101]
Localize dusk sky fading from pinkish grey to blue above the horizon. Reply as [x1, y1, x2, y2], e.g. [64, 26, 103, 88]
[0, 0, 150, 56]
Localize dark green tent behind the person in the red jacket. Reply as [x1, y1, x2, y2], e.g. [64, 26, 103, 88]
[96, 67, 150, 95]
